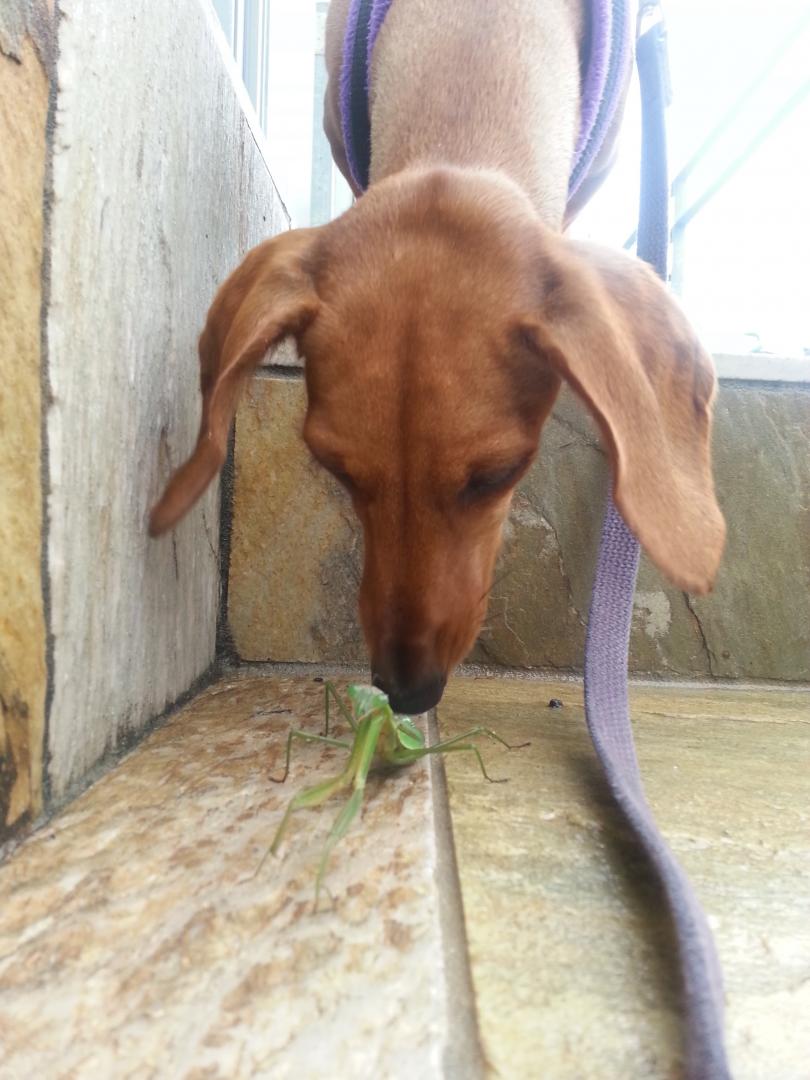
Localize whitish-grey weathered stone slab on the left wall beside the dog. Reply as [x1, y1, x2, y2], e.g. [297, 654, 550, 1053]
[48, 0, 285, 797]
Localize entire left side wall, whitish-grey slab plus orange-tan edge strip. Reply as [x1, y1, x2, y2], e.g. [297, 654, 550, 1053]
[0, 0, 288, 840]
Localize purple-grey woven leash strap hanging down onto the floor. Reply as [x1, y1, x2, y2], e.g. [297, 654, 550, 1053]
[585, 10, 731, 1080]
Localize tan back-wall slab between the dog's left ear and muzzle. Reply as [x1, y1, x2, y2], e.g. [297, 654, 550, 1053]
[228, 377, 365, 662]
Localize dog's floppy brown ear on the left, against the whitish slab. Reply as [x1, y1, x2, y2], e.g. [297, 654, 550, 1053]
[149, 229, 318, 537]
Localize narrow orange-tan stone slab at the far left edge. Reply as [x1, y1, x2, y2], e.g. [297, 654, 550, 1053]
[0, 23, 50, 843]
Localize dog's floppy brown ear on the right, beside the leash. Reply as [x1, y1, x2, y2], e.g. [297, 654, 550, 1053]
[522, 236, 726, 593]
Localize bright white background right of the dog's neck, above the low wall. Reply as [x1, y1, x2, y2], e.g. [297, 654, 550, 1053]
[576, 0, 810, 362]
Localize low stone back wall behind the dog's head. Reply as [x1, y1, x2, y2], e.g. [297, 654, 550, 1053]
[229, 374, 810, 681]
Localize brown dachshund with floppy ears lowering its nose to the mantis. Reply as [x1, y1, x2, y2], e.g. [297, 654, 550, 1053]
[150, 0, 725, 714]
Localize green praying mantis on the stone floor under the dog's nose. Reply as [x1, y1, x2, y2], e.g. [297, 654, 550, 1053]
[256, 683, 528, 908]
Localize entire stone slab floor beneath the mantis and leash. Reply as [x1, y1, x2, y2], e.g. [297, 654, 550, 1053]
[0, 672, 810, 1080]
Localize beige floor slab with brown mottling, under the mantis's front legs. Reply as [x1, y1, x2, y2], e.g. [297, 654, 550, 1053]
[0, 677, 476, 1080]
